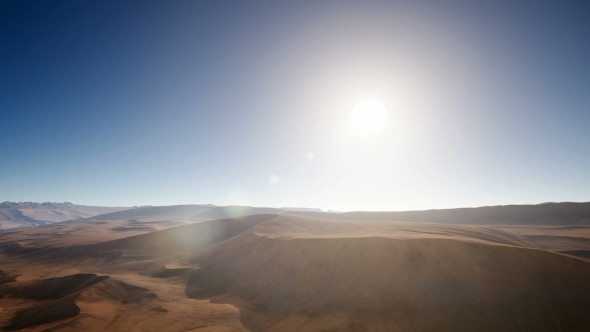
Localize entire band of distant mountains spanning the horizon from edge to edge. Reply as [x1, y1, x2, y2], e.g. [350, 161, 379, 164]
[0, 202, 590, 230]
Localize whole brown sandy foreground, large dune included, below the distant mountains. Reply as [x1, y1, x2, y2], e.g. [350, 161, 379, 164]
[0, 214, 590, 332]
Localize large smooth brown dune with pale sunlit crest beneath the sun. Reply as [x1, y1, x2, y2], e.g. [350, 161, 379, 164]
[186, 216, 590, 331]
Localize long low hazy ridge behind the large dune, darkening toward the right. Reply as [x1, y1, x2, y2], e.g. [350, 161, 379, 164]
[84, 202, 590, 226]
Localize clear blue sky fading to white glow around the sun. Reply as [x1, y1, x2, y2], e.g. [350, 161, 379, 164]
[0, 0, 590, 211]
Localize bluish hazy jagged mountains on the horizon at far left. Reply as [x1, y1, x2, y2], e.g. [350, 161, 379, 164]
[0, 202, 129, 229]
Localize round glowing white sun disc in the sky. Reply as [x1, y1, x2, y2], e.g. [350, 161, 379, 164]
[350, 99, 387, 136]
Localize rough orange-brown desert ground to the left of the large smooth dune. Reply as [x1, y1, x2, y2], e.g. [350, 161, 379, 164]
[0, 215, 276, 331]
